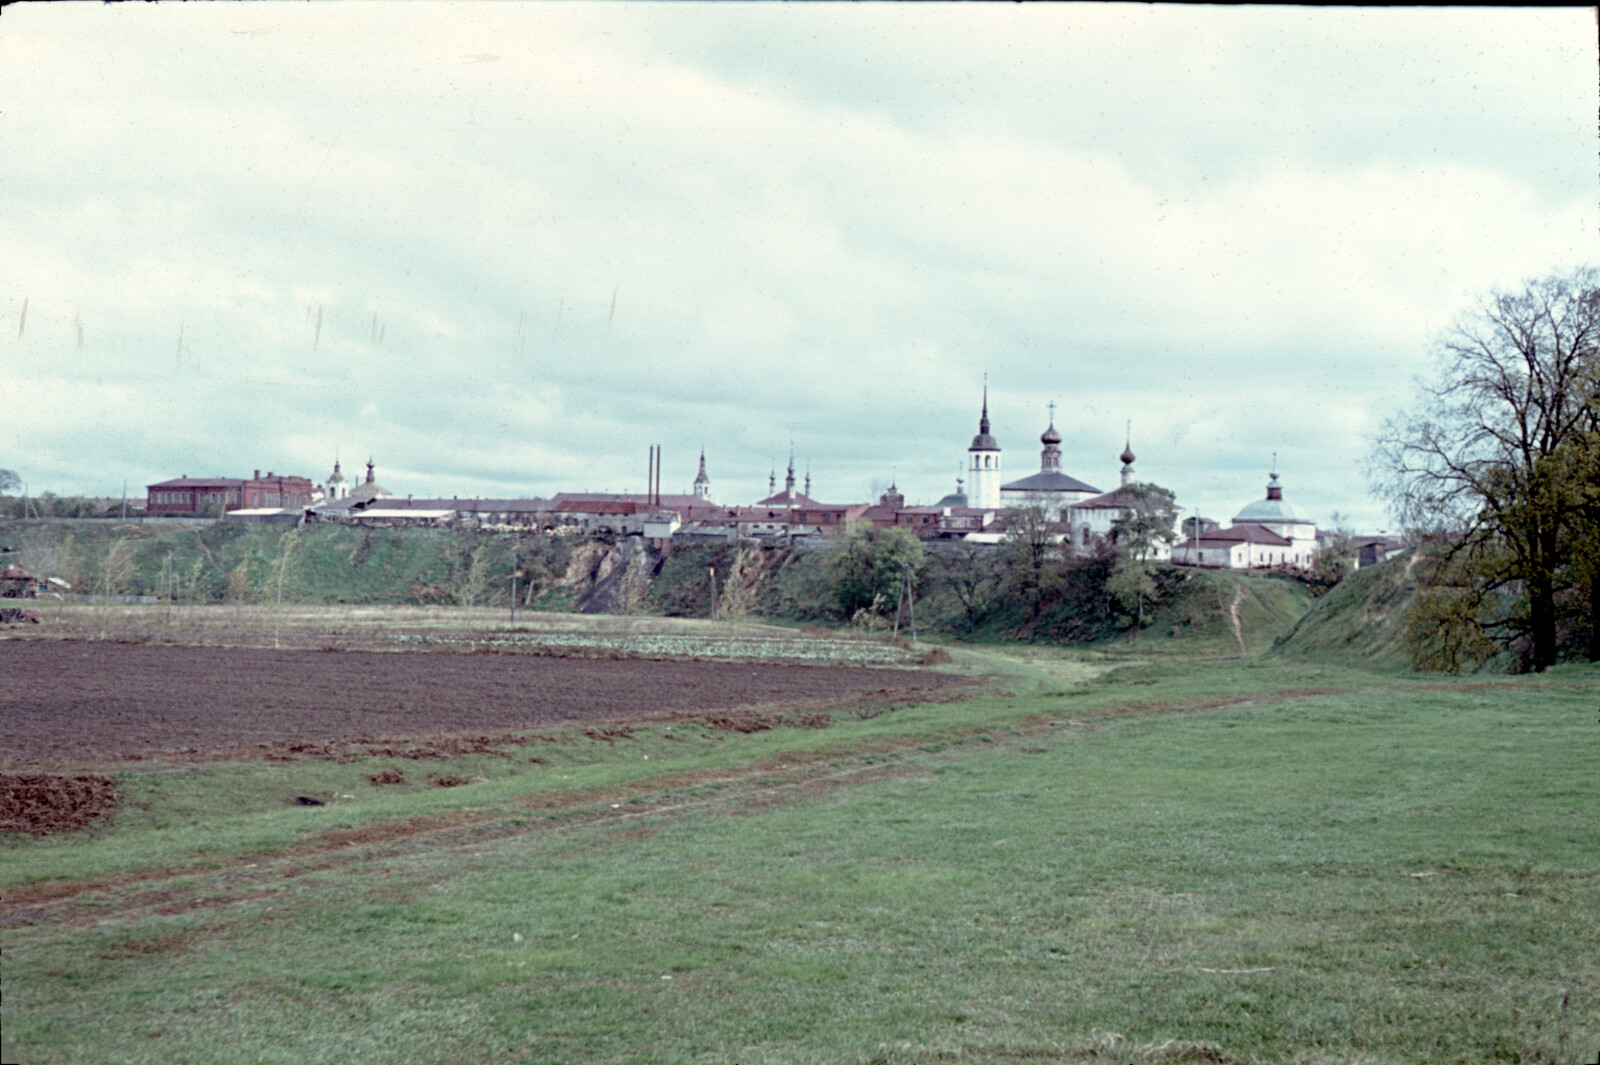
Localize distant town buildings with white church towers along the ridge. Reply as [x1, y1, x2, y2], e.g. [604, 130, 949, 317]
[118, 381, 1356, 569]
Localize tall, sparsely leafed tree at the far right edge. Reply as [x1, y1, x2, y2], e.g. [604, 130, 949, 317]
[1371, 269, 1600, 670]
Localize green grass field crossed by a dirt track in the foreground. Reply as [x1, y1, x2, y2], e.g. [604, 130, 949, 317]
[0, 614, 1600, 1065]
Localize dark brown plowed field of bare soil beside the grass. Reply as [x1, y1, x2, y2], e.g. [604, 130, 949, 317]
[0, 641, 963, 769]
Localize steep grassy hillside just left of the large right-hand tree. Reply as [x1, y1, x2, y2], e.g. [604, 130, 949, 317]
[1272, 552, 1416, 670]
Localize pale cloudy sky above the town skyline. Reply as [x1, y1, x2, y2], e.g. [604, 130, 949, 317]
[0, 3, 1600, 531]
